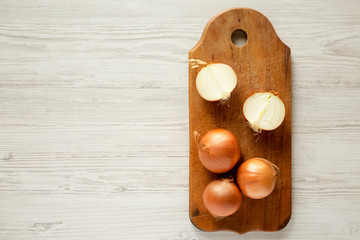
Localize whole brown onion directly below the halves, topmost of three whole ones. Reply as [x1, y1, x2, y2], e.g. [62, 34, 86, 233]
[194, 129, 241, 173]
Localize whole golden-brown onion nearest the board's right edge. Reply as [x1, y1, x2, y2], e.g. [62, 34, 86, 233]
[236, 158, 280, 199]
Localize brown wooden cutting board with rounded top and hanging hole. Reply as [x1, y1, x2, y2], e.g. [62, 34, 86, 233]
[189, 8, 291, 233]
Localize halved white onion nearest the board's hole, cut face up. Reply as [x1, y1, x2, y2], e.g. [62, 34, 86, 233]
[196, 63, 237, 101]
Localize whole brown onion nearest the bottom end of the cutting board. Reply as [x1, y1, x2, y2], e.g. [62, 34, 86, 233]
[203, 179, 242, 220]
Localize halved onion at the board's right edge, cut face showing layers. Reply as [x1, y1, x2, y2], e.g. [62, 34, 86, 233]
[243, 92, 285, 132]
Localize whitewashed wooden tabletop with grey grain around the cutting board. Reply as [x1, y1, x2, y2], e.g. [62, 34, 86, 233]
[0, 0, 360, 240]
